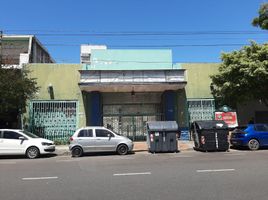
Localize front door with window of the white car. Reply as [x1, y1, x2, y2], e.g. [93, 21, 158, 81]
[1, 130, 27, 155]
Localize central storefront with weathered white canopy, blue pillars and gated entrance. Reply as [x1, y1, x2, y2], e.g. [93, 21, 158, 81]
[79, 69, 186, 141]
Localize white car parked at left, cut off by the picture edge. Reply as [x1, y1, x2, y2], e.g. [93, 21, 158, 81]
[0, 129, 55, 159]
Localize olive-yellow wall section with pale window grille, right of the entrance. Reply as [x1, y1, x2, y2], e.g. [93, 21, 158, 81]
[181, 63, 219, 128]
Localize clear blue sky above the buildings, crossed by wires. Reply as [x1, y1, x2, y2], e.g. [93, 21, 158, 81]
[0, 0, 268, 63]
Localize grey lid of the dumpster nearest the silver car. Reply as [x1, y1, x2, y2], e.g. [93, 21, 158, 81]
[147, 121, 178, 131]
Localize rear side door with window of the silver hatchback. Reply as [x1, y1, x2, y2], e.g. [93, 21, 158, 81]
[77, 129, 96, 152]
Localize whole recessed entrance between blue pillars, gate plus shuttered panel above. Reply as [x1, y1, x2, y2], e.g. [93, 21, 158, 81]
[102, 93, 162, 141]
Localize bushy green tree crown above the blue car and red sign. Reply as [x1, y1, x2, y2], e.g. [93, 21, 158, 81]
[211, 42, 268, 107]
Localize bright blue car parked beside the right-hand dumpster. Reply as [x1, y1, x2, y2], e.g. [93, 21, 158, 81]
[230, 124, 268, 150]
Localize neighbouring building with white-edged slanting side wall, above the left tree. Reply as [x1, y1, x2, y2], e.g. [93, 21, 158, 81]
[0, 35, 55, 68]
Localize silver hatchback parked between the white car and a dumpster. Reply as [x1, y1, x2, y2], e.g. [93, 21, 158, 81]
[69, 126, 133, 157]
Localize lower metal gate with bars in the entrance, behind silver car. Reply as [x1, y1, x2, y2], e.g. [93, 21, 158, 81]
[103, 104, 162, 141]
